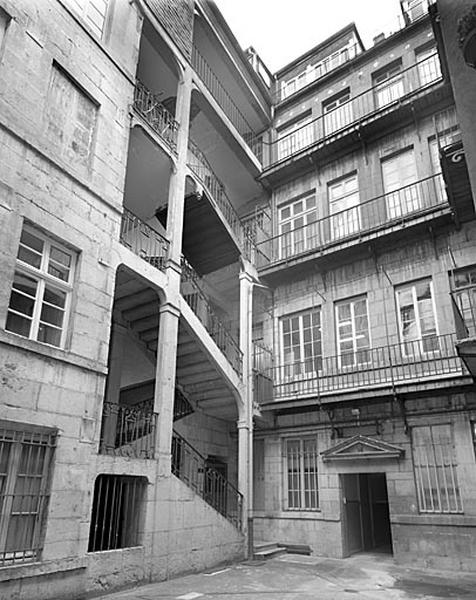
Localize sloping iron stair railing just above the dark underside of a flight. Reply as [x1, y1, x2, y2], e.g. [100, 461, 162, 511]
[188, 140, 244, 244]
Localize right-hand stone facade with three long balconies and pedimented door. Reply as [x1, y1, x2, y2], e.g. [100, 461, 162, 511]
[249, 2, 476, 571]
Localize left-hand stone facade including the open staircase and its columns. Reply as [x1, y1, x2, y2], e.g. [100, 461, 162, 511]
[0, 0, 270, 600]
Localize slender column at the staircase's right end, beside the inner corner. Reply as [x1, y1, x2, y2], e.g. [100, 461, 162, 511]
[238, 268, 253, 557]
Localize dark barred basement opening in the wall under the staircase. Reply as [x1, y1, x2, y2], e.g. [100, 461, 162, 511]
[88, 475, 147, 552]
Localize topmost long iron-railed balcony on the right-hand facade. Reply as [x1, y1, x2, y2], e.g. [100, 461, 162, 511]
[263, 53, 443, 177]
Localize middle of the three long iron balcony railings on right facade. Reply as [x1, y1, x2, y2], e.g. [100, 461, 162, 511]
[256, 174, 448, 267]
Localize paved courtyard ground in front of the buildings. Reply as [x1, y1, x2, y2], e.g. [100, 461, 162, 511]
[92, 554, 476, 600]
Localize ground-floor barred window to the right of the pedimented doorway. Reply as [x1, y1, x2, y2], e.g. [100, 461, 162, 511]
[412, 425, 463, 513]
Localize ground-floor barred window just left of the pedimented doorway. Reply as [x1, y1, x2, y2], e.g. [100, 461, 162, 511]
[285, 437, 319, 510]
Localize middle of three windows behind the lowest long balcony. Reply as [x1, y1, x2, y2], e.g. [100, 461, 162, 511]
[336, 297, 370, 367]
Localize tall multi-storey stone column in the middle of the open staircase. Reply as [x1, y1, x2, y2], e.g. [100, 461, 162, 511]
[154, 66, 192, 476]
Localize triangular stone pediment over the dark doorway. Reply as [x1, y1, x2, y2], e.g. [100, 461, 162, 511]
[321, 435, 405, 461]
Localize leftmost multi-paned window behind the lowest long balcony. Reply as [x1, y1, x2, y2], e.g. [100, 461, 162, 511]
[281, 308, 322, 377]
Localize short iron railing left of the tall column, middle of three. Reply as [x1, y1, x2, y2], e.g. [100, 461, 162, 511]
[119, 208, 169, 270]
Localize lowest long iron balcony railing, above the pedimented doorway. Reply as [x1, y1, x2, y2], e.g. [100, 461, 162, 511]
[262, 334, 466, 401]
